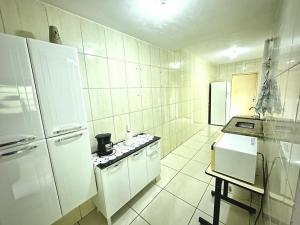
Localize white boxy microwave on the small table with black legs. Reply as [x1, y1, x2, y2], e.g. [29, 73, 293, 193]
[211, 133, 260, 184]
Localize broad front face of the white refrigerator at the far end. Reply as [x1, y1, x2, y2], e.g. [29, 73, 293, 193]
[210, 81, 226, 125]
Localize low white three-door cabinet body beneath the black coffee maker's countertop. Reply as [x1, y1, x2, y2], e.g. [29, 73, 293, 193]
[94, 141, 160, 224]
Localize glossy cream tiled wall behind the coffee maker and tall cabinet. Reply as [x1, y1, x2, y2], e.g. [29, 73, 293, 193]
[0, 0, 216, 225]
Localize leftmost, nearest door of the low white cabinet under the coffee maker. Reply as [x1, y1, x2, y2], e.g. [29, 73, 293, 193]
[102, 158, 130, 217]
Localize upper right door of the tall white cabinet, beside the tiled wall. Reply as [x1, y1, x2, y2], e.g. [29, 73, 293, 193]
[27, 39, 87, 137]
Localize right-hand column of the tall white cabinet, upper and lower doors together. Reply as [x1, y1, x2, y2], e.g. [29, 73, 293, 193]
[27, 39, 97, 215]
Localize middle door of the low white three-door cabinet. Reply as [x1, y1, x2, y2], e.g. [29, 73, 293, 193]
[128, 149, 147, 197]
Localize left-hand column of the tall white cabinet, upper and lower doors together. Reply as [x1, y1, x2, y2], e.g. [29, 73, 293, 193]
[0, 34, 61, 225]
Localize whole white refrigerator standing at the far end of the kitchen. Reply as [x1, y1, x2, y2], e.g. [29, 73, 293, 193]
[209, 81, 231, 126]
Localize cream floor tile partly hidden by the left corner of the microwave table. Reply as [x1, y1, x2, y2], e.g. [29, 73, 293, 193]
[181, 160, 212, 183]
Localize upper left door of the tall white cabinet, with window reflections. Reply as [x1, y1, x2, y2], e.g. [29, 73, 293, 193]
[0, 34, 44, 150]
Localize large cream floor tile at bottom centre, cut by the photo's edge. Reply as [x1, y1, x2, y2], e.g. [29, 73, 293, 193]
[141, 190, 195, 225]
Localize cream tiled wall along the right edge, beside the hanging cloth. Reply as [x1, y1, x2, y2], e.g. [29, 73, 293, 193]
[264, 0, 300, 224]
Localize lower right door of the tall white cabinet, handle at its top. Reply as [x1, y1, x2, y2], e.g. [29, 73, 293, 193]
[47, 130, 97, 215]
